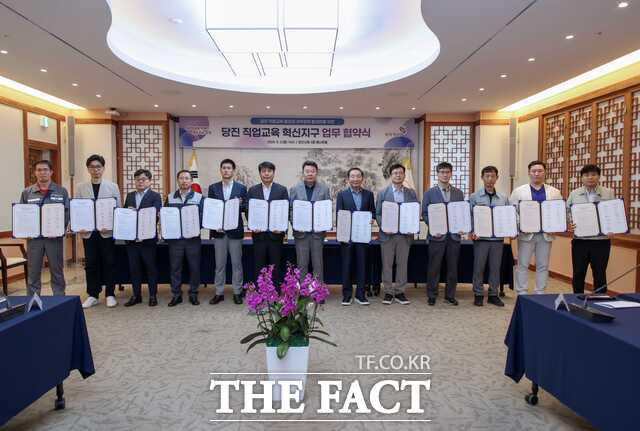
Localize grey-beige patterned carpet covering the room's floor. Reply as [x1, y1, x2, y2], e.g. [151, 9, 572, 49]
[4, 267, 593, 431]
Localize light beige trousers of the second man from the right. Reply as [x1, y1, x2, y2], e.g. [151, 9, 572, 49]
[516, 233, 552, 295]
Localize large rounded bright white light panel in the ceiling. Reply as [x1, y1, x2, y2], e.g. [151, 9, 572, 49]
[107, 0, 440, 94]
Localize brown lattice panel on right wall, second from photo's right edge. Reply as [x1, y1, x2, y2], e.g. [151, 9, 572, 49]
[596, 96, 624, 196]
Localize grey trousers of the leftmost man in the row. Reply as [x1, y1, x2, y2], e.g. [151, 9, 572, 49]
[27, 238, 66, 296]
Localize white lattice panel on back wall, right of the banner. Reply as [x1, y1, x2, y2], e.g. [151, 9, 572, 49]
[429, 125, 472, 198]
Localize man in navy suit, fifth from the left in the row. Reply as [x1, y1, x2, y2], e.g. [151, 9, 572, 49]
[208, 159, 247, 305]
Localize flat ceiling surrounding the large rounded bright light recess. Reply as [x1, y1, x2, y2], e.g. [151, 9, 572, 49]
[0, 0, 640, 117]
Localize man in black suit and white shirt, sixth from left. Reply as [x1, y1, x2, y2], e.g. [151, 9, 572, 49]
[247, 162, 289, 286]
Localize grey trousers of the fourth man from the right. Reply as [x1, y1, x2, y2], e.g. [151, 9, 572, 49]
[427, 235, 460, 298]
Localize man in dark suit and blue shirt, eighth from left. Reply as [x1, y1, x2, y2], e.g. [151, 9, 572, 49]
[336, 168, 376, 305]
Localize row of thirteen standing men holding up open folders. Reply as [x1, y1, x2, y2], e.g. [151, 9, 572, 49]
[20, 155, 615, 308]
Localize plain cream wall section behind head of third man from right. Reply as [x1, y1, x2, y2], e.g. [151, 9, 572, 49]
[475, 125, 511, 195]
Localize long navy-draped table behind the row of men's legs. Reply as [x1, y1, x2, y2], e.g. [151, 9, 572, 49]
[114, 240, 514, 289]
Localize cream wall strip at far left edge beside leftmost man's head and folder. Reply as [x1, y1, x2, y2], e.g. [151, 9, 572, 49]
[0, 105, 24, 231]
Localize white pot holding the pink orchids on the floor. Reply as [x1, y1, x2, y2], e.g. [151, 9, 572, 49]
[266, 346, 309, 401]
